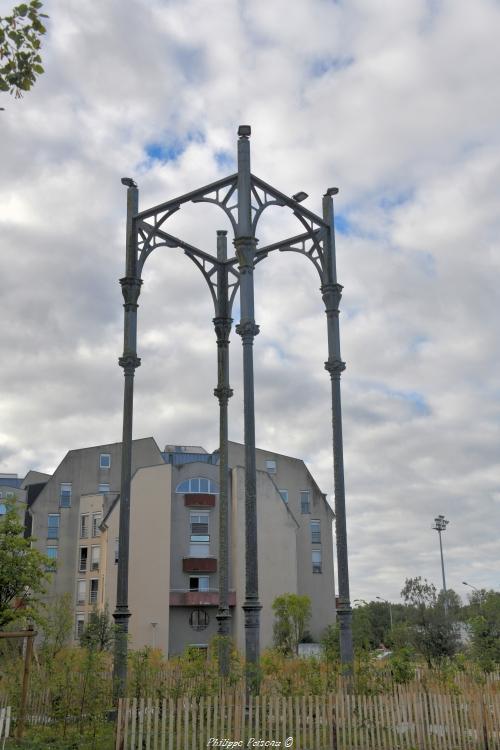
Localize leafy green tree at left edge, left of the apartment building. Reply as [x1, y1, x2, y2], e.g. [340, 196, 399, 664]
[0, 503, 51, 628]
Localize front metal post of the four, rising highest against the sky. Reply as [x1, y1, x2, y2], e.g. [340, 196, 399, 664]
[234, 125, 262, 691]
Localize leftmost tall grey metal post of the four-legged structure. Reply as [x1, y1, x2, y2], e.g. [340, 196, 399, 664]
[113, 178, 142, 701]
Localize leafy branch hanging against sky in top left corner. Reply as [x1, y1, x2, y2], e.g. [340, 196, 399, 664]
[0, 0, 48, 99]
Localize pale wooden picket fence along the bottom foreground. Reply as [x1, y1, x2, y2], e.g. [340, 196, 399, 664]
[116, 688, 500, 750]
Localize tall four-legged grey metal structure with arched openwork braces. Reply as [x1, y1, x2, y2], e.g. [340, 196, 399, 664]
[113, 125, 353, 696]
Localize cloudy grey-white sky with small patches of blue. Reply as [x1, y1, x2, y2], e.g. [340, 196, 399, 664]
[0, 0, 500, 601]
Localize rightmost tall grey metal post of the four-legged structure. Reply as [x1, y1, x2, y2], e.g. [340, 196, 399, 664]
[321, 188, 354, 674]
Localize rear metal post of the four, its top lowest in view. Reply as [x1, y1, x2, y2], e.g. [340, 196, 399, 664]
[213, 229, 233, 677]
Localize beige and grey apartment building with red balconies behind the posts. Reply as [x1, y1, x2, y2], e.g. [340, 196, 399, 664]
[31, 438, 335, 655]
